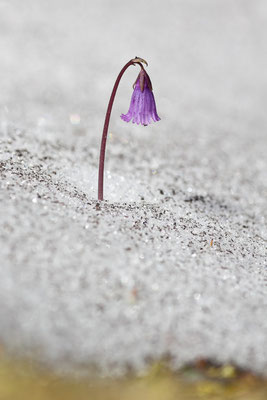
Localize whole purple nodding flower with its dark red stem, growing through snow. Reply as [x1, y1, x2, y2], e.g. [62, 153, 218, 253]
[98, 57, 160, 200]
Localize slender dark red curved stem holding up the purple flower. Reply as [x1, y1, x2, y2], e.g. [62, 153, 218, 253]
[98, 60, 140, 200]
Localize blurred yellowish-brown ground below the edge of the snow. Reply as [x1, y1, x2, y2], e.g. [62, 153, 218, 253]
[0, 359, 267, 400]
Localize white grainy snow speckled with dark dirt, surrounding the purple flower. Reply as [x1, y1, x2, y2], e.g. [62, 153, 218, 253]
[0, 0, 267, 375]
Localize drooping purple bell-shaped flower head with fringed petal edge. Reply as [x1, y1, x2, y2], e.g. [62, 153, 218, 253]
[121, 68, 160, 126]
